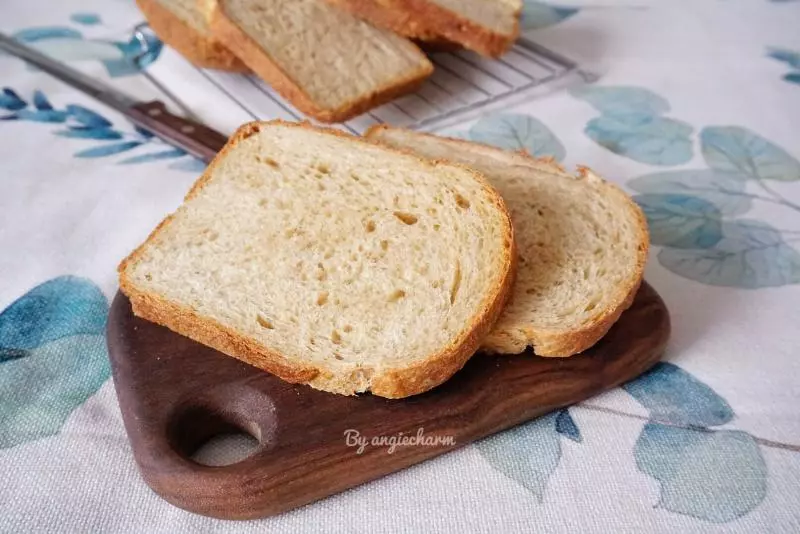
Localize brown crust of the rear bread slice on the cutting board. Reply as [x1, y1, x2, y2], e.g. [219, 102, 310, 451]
[364, 125, 650, 357]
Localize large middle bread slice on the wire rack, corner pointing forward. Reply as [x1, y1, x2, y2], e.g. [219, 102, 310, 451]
[206, 0, 433, 122]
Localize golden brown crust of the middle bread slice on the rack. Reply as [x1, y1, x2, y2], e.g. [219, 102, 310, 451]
[206, 2, 433, 123]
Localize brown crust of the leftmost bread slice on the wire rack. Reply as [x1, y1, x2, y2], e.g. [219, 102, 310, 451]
[136, 0, 249, 72]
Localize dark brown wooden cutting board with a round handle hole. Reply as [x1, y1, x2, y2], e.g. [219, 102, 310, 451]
[108, 284, 670, 519]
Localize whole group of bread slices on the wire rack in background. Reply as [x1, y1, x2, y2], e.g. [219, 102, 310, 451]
[137, 0, 522, 122]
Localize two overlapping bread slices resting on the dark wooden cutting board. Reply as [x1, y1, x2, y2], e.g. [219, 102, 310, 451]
[119, 121, 649, 398]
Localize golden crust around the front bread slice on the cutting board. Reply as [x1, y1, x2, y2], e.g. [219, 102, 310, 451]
[117, 120, 517, 398]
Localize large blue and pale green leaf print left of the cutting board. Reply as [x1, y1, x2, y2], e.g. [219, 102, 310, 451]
[0, 276, 109, 448]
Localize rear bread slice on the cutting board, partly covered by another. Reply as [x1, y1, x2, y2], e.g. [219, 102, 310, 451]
[366, 126, 649, 356]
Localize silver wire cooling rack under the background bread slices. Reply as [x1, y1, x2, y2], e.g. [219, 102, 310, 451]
[188, 38, 589, 134]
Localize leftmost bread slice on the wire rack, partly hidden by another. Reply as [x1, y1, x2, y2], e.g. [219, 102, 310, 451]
[136, 0, 249, 72]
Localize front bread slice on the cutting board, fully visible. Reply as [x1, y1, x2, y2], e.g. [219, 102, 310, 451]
[119, 122, 516, 398]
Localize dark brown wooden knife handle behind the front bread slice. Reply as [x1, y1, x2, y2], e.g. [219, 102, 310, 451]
[128, 100, 228, 163]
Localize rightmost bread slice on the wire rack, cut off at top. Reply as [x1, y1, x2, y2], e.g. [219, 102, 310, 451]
[327, 0, 522, 57]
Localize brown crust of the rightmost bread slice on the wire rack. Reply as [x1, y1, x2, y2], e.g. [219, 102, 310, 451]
[326, 0, 520, 57]
